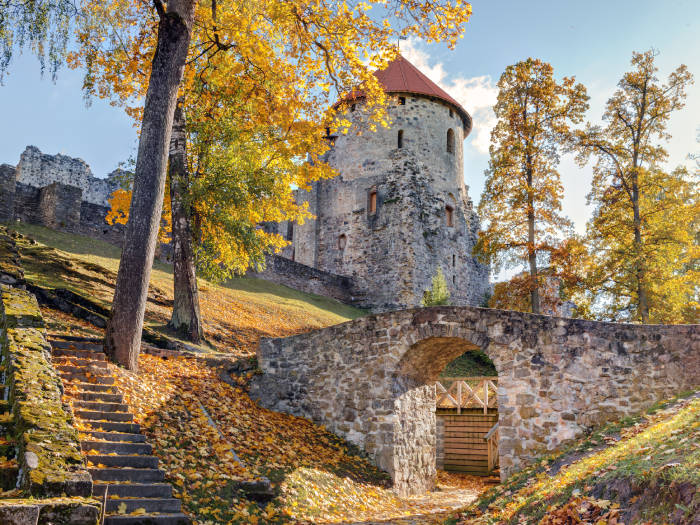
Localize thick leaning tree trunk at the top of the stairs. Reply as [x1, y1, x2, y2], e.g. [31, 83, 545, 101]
[105, 0, 196, 370]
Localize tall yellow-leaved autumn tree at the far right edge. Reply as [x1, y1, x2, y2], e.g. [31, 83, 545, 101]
[578, 51, 700, 323]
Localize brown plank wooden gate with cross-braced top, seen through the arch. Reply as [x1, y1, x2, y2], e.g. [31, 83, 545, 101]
[435, 377, 498, 476]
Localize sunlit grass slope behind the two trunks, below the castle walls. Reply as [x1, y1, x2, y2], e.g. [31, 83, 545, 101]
[12, 224, 366, 355]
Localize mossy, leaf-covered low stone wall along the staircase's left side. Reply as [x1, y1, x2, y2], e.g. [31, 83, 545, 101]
[0, 285, 92, 498]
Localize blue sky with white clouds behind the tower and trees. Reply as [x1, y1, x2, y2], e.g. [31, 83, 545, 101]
[0, 0, 700, 231]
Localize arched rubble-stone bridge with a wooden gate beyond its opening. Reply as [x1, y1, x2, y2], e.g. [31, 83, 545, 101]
[251, 306, 700, 494]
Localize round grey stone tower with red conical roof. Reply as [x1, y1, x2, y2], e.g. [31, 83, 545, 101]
[287, 57, 489, 310]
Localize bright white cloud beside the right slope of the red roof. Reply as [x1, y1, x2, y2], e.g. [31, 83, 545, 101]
[401, 40, 498, 153]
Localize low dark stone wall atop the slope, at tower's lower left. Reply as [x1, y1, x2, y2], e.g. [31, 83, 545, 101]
[247, 255, 357, 304]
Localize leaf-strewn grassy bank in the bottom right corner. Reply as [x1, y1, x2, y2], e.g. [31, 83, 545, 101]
[446, 391, 700, 525]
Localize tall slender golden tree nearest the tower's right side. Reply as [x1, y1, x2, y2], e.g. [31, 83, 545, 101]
[476, 58, 588, 313]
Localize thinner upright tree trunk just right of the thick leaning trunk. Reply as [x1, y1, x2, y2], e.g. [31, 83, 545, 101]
[168, 99, 202, 343]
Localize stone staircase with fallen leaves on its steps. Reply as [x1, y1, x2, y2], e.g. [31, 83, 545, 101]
[49, 337, 191, 525]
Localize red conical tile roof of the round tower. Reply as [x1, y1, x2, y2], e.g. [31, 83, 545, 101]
[340, 55, 472, 136]
